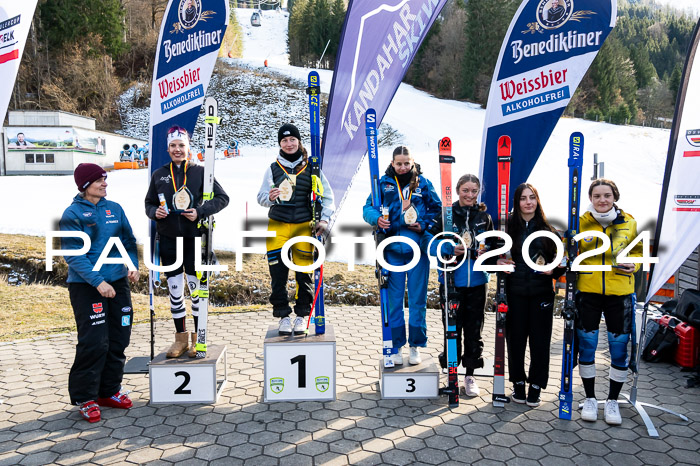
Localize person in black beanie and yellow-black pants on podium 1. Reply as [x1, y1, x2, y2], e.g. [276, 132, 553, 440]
[258, 123, 335, 335]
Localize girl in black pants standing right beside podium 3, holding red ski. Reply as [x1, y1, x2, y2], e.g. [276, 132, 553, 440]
[430, 175, 495, 396]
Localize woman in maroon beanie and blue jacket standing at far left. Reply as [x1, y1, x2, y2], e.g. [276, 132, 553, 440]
[59, 163, 139, 422]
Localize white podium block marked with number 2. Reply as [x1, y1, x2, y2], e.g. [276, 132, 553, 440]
[148, 345, 228, 404]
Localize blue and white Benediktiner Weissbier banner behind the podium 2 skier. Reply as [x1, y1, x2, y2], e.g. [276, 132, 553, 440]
[149, 0, 229, 173]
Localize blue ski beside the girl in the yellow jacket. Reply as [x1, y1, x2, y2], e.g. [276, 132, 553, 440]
[559, 132, 583, 420]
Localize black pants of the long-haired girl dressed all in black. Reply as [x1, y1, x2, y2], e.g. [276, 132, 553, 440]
[506, 291, 554, 388]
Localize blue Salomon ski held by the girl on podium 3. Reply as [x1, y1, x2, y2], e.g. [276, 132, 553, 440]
[365, 108, 394, 367]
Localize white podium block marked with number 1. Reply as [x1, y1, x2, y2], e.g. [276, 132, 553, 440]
[263, 325, 336, 403]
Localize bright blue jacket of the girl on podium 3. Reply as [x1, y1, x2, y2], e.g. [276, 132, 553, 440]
[362, 169, 442, 256]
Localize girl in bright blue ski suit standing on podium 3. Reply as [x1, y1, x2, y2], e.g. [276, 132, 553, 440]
[362, 146, 442, 365]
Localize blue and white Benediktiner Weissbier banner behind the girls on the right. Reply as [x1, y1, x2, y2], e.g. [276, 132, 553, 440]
[479, 0, 617, 216]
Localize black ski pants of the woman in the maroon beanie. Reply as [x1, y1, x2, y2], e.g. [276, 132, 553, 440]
[68, 277, 134, 404]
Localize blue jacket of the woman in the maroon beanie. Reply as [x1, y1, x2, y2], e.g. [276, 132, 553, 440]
[59, 194, 139, 287]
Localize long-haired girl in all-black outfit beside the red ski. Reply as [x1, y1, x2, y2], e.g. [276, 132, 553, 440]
[497, 183, 564, 407]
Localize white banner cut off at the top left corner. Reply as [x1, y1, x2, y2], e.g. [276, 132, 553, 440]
[0, 0, 37, 126]
